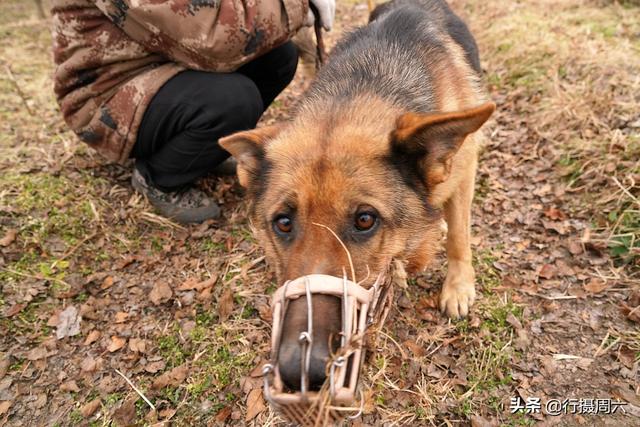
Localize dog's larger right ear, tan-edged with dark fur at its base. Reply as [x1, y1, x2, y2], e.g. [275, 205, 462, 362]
[391, 102, 496, 186]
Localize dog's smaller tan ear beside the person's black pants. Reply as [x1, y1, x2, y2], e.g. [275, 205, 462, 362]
[218, 125, 281, 188]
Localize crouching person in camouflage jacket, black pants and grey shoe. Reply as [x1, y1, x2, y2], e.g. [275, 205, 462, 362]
[52, 0, 335, 223]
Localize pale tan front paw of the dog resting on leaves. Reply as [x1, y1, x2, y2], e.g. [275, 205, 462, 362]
[440, 264, 476, 319]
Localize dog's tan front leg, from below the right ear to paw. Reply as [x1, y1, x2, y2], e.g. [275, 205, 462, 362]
[440, 167, 476, 318]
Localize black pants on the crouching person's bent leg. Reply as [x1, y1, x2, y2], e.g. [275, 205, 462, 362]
[131, 42, 298, 191]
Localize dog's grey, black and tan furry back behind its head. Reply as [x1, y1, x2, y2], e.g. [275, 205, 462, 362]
[302, 0, 483, 113]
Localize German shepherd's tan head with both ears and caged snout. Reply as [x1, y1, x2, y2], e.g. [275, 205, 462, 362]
[220, 100, 494, 389]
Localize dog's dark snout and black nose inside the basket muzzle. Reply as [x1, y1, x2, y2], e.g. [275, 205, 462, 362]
[278, 295, 342, 391]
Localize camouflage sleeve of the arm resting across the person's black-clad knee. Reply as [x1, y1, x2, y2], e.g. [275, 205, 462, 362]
[95, 0, 309, 72]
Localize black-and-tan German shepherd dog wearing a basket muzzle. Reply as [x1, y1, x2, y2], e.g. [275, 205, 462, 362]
[220, 0, 495, 390]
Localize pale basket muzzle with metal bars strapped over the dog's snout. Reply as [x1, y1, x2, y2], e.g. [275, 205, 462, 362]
[263, 274, 393, 426]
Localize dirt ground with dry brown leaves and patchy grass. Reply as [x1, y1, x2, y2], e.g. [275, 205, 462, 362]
[0, 0, 640, 426]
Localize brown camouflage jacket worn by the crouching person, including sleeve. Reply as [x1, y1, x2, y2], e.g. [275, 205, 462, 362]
[52, 0, 309, 162]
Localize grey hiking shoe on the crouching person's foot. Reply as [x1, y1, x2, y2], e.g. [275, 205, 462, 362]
[131, 168, 220, 224]
